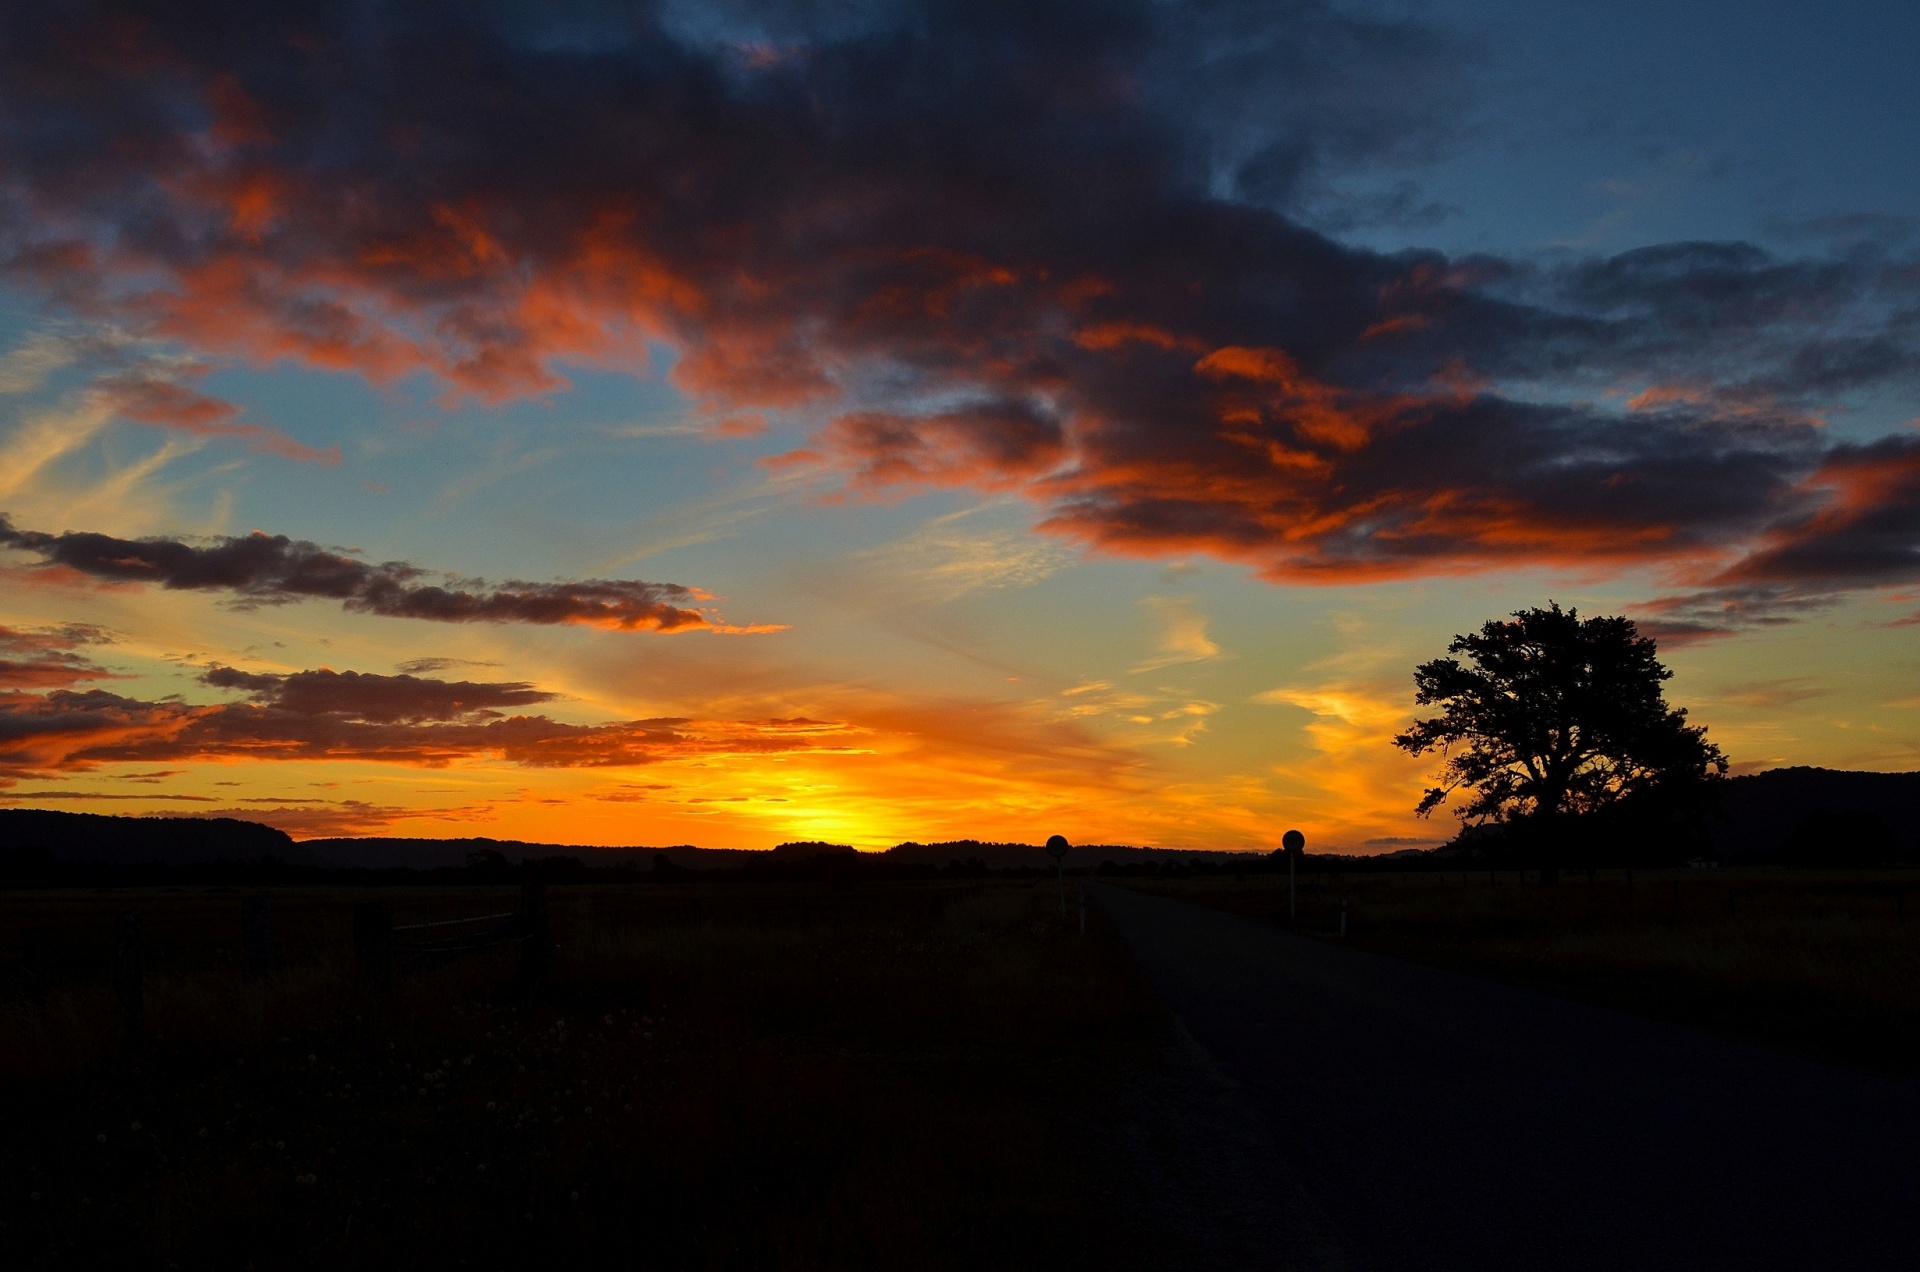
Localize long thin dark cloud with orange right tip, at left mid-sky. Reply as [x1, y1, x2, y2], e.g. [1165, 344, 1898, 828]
[0, 515, 760, 632]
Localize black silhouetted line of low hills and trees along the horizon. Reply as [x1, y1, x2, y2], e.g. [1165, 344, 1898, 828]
[0, 769, 1920, 888]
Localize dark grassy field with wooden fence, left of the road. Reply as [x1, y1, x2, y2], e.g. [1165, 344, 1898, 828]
[0, 882, 1165, 1268]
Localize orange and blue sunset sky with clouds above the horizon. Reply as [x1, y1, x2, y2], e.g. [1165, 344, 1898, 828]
[0, 0, 1920, 851]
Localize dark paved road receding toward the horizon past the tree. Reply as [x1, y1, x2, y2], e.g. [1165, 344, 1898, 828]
[1098, 886, 1920, 1272]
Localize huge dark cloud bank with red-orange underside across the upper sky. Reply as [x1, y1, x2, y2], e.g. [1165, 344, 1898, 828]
[0, 0, 1920, 607]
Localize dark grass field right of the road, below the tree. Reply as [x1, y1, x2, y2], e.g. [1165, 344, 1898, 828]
[1129, 868, 1920, 1074]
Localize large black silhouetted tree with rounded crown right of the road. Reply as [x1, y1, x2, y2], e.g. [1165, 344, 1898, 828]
[1394, 603, 1726, 874]
